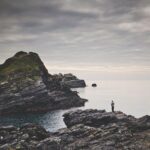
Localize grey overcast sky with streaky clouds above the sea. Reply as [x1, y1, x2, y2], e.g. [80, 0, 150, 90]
[0, 0, 150, 79]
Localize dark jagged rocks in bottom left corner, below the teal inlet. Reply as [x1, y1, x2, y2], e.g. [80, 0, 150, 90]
[0, 124, 50, 150]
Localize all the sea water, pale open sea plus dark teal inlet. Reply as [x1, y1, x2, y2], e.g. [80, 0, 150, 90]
[0, 80, 150, 132]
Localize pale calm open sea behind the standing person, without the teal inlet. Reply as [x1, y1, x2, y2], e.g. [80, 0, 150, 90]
[78, 80, 150, 117]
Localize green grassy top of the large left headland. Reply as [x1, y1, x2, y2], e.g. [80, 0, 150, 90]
[0, 53, 41, 81]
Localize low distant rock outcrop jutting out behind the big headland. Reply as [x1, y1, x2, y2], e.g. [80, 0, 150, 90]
[55, 73, 86, 88]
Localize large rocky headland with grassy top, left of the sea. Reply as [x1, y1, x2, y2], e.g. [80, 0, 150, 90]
[0, 52, 86, 115]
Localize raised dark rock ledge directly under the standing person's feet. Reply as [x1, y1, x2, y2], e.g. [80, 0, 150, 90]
[64, 109, 136, 127]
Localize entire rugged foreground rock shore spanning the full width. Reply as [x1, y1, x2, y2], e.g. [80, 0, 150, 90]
[0, 110, 150, 150]
